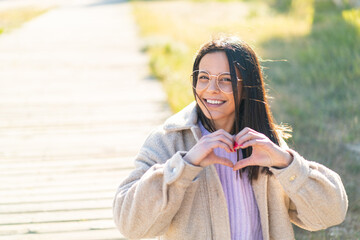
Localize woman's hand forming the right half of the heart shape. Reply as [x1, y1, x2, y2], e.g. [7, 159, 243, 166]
[233, 127, 293, 171]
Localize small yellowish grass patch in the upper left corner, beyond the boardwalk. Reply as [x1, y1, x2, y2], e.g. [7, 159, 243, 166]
[0, 7, 48, 34]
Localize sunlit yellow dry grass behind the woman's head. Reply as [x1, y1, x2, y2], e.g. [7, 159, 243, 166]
[133, 1, 311, 112]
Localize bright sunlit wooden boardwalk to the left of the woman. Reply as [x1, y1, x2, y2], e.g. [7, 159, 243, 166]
[0, 1, 170, 240]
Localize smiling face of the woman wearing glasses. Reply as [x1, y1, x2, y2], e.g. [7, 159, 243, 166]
[196, 51, 241, 132]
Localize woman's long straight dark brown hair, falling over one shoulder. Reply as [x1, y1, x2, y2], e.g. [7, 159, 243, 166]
[192, 37, 290, 180]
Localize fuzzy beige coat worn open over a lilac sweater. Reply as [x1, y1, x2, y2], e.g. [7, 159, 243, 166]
[113, 103, 348, 240]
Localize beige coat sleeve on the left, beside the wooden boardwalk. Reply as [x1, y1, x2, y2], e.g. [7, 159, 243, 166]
[113, 128, 203, 238]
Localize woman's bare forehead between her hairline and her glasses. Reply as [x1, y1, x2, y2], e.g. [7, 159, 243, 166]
[199, 51, 230, 74]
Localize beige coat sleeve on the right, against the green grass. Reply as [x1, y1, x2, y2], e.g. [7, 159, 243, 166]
[270, 149, 348, 231]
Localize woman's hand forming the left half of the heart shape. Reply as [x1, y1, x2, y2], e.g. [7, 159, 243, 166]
[184, 129, 235, 167]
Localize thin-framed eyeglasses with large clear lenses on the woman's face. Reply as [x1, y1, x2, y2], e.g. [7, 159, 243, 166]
[191, 70, 241, 93]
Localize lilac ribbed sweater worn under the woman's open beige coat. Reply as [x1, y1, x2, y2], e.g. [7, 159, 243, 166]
[199, 123, 263, 240]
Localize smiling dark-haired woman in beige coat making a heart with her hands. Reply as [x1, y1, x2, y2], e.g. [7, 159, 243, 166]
[113, 38, 348, 240]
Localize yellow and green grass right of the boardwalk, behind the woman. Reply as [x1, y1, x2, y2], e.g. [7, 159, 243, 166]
[133, 0, 360, 239]
